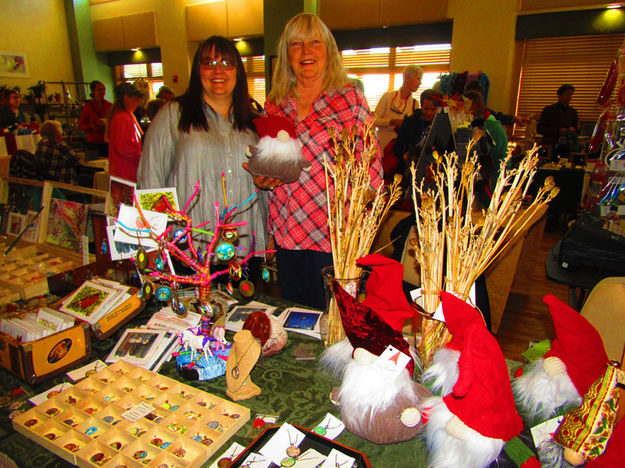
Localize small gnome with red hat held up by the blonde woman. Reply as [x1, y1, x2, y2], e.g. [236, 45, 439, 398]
[246, 115, 310, 184]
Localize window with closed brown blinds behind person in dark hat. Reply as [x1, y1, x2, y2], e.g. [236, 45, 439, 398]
[515, 34, 625, 134]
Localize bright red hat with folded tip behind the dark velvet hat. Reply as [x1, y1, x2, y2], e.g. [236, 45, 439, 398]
[356, 254, 414, 332]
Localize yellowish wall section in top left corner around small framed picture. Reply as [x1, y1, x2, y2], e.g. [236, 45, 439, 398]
[0, 0, 74, 94]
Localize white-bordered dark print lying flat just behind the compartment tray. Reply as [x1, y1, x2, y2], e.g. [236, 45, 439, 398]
[106, 328, 167, 367]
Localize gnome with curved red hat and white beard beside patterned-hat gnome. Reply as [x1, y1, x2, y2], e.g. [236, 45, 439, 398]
[512, 295, 608, 424]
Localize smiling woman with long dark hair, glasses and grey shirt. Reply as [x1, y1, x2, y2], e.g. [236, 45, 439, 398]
[138, 36, 266, 260]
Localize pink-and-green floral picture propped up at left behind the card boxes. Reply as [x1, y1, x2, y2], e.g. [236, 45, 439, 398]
[46, 198, 88, 251]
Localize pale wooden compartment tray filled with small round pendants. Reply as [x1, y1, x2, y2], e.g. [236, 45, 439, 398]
[13, 361, 250, 468]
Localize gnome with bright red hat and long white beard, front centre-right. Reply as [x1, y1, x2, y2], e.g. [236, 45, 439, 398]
[424, 292, 523, 468]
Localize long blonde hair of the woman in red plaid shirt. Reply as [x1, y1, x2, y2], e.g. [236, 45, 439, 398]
[269, 13, 349, 104]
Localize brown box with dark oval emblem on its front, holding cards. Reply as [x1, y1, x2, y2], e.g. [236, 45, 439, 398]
[0, 323, 91, 384]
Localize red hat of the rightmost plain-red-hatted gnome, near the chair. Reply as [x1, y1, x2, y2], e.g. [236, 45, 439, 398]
[543, 295, 608, 395]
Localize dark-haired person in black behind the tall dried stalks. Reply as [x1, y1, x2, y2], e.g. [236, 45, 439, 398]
[392, 89, 447, 188]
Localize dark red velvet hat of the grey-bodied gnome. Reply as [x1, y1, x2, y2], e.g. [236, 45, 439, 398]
[332, 280, 414, 375]
